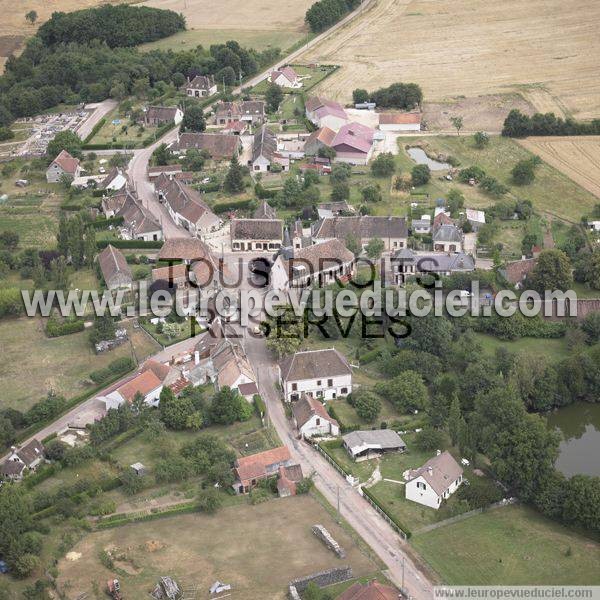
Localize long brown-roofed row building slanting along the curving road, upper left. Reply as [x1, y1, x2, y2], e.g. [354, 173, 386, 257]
[154, 174, 221, 237]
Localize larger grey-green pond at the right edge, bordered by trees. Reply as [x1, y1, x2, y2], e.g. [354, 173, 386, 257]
[548, 402, 600, 476]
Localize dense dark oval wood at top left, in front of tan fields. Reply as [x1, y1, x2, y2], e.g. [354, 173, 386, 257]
[36, 4, 185, 48]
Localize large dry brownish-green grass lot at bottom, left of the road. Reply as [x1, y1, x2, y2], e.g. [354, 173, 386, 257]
[58, 496, 378, 600]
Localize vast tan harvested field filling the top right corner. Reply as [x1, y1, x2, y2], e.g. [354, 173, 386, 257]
[302, 0, 600, 119]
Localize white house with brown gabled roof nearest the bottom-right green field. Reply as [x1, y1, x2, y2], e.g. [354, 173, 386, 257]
[404, 451, 463, 510]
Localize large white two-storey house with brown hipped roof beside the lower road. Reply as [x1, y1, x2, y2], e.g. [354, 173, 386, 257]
[279, 348, 352, 402]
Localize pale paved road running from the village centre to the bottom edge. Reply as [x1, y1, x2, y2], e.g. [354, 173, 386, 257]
[241, 337, 433, 599]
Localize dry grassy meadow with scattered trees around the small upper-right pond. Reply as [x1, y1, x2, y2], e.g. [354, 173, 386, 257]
[399, 136, 597, 223]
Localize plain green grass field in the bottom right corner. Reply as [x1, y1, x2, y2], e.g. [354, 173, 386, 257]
[411, 506, 600, 585]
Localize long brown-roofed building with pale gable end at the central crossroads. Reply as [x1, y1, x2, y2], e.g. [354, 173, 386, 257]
[271, 239, 354, 290]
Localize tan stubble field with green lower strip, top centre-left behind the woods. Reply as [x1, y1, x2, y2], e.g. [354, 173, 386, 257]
[143, 0, 313, 50]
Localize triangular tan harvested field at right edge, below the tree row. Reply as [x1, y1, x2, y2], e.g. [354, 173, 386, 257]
[519, 136, 600, 198]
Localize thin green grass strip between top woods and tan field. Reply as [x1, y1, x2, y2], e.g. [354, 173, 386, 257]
[140, 29, 306, 51]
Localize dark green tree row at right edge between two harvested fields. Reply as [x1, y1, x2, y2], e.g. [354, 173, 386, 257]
[502, 109, 600, 138]
